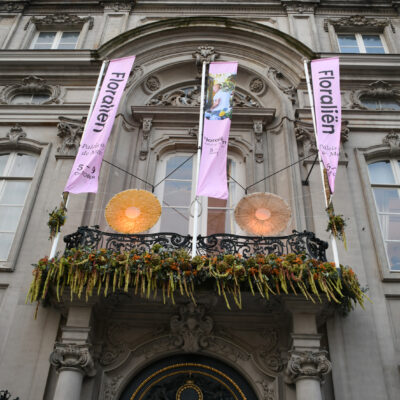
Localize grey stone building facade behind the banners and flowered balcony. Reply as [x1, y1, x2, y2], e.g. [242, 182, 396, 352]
[0, 0, 400, 400]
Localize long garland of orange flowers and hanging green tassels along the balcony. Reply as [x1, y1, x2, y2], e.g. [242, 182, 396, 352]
[27, 245, 367, 313]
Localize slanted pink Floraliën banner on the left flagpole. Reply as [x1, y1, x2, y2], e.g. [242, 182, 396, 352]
[64, 56, 135, 193]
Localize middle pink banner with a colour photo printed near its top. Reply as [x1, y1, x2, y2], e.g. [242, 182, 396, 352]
[196, 62, 238, 199]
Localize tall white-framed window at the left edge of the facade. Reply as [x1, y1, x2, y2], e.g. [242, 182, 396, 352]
[0, 152, 37, 261]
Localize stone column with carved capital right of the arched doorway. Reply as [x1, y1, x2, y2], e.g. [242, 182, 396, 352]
[286, 299, 331, 400]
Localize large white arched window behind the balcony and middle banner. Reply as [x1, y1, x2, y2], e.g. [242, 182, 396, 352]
[153, 153, 244, 235]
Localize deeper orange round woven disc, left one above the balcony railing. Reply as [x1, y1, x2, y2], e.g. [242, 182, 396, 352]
[105, 189, 161, 233]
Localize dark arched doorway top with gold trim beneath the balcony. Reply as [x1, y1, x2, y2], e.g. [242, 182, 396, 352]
[120, 354, 257, 400]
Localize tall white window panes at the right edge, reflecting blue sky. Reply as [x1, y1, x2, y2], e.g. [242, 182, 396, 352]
[368, 159, 400, 271]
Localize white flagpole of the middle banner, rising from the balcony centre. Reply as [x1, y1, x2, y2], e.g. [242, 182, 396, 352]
[192, 61, 207, 258]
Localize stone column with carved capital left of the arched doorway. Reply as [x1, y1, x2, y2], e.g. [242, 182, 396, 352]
[50, 306, 96, 400]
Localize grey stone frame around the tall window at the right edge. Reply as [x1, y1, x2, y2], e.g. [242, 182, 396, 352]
[354, 143, 400, 282]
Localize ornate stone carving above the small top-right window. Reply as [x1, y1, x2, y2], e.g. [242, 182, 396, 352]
[324, 15, 395, 33]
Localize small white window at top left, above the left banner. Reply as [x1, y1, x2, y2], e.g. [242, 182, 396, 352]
[31, 31, 80, 50]
